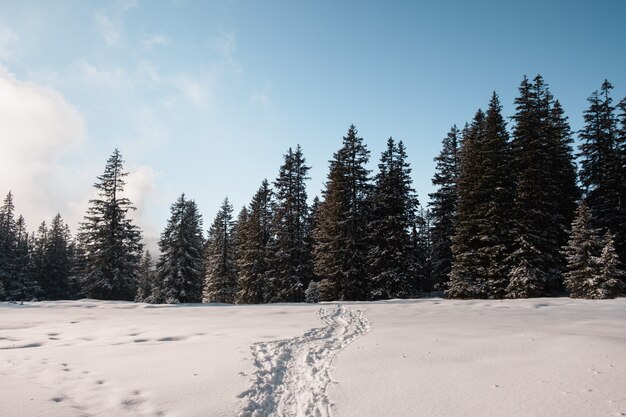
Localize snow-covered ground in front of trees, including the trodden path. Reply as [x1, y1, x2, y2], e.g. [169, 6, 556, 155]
[0, 299, 626, 417]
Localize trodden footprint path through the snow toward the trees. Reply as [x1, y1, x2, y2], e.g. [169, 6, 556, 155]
[239, 305, 371, 417]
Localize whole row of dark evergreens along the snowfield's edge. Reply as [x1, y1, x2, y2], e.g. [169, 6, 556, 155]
[0, 76, 626, 304]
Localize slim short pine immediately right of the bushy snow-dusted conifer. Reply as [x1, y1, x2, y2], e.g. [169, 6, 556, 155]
[202, 198, 237, 303]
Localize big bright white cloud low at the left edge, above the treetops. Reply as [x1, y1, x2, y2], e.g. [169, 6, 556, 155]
[0, 68, 86, 229]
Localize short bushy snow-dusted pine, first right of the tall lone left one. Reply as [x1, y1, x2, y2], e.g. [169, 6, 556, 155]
[152, 194, 204, 304]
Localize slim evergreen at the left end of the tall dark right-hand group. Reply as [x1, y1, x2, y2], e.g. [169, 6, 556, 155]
[429, 125, 460, 290]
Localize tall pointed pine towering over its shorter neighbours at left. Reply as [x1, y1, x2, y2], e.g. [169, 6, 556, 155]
[79, 149, 142, 300]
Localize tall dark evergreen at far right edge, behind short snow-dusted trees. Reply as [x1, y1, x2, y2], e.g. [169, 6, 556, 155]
[579, 80, 626, 262]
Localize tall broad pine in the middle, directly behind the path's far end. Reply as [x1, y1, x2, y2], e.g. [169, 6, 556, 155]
[313, 125, 372, 300]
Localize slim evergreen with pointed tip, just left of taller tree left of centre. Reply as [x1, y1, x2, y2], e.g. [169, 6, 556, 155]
[237, 180, 273, 304]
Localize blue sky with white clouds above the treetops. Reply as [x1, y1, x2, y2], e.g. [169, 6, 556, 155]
[0, 0, 626, 250]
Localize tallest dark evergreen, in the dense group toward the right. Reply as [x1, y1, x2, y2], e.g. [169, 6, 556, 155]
[506, 75, 577, 298]
